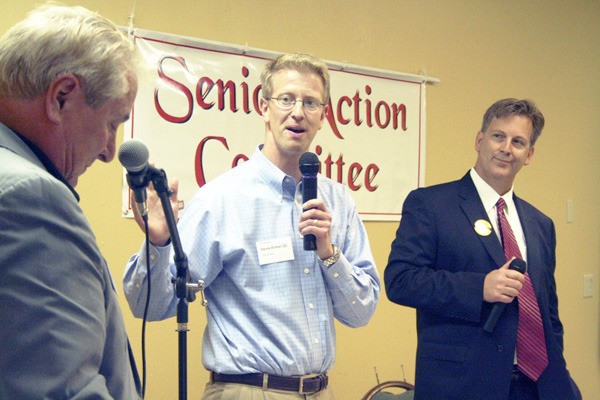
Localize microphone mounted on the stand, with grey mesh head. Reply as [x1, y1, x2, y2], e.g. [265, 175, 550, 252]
[119, 139, 150, 216]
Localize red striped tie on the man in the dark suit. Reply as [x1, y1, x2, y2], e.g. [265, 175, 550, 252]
[496, 198, 548, 382]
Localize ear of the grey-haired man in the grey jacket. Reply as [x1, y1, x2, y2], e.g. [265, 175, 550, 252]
[46, 74, 83, 123]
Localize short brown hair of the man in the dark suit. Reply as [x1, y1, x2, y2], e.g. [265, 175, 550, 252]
[481, 98, 545, 146]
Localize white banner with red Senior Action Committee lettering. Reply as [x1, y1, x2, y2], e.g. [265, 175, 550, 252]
[123, 30, 435, 221]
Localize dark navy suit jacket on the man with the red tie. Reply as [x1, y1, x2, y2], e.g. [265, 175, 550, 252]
[384, 173, 577, 400]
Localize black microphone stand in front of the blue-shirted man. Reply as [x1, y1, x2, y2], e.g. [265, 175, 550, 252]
[148, 168, 207, 400]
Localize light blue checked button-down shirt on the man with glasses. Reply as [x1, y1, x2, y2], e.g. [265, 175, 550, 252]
[124, 148, 380, 376]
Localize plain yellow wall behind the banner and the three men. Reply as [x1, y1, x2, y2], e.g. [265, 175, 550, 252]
[0, 0, 600, 400]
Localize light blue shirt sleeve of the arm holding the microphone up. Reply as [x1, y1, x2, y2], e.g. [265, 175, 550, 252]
[321, 192, 380, 328]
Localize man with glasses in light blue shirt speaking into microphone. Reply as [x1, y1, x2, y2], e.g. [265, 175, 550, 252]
[124, 54, 380, 400]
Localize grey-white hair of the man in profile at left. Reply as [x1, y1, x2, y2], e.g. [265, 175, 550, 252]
[0, 4, 142, 108]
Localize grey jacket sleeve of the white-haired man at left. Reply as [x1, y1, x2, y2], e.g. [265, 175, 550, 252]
[0, 176, 113, 399]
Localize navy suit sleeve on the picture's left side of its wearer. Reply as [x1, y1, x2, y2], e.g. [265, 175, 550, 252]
[384, 189, 485, 322]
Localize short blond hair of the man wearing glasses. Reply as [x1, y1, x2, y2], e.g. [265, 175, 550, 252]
[260, 53, 331, 103]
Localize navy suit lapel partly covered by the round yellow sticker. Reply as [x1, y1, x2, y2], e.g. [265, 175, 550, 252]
[458, 173, 506, 267]
